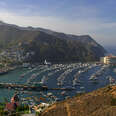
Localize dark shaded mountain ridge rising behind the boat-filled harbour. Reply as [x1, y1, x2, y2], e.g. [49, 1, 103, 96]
[0, 22, 106, 62]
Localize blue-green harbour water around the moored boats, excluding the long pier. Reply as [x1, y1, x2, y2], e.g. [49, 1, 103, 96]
[0, 64, 116, 102]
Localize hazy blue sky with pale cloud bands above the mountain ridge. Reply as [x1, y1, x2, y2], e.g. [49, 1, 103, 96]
[0, 0, 116, 45]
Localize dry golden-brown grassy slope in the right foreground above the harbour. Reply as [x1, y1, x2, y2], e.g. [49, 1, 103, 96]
[41, 86, 116, 116]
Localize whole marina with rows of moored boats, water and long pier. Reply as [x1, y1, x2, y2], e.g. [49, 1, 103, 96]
[0, 63, 116, 101]
